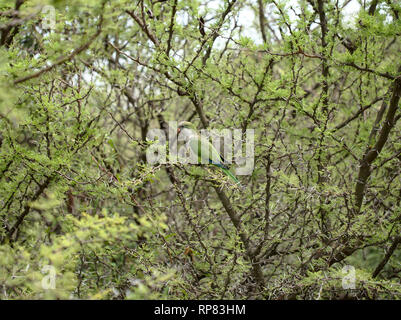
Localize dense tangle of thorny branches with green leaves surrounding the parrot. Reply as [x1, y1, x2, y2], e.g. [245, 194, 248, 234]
[0, 0, 401, 299]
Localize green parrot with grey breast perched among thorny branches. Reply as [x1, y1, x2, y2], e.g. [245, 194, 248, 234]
[177, 121, 241, 186]
